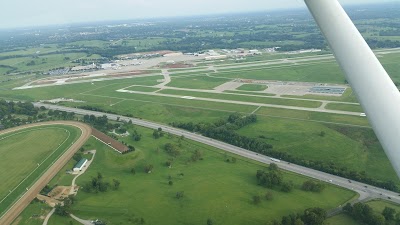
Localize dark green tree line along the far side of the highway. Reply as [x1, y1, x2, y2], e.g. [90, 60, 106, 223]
[170, 113, 399, 192]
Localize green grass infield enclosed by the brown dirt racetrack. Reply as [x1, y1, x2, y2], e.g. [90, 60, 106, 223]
[0, 125, 80, 217]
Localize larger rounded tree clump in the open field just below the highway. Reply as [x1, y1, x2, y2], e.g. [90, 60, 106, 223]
[256, 163, 293, 192]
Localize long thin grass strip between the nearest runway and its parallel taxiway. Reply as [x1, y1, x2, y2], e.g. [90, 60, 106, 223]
[158, 89, 322, 108]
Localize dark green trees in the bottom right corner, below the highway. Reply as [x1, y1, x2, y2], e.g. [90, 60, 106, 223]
[343, 202, 390, 225]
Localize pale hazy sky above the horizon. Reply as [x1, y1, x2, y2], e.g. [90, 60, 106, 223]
[0, 0, 398, 29]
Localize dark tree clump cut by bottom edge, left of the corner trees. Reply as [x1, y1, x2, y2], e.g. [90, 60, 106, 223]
[269, 208, 327, 225]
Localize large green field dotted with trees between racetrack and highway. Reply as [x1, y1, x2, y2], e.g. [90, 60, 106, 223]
[62, 127, 354, 225]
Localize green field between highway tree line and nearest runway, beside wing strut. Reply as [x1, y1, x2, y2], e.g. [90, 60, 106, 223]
[238, 117, 400, 184]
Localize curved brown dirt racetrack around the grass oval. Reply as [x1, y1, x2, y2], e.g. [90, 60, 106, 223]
[0, 121, 92, 224]
